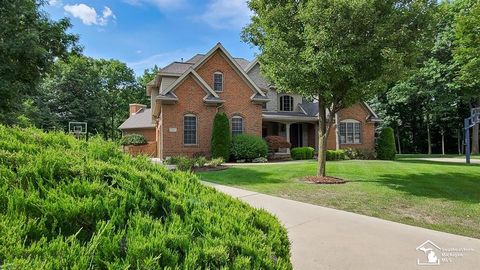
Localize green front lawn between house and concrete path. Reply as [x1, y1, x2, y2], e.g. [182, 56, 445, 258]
[200, 160, 480, 238]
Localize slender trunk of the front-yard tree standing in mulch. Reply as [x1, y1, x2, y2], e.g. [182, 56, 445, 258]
[317, 99, 328, 177]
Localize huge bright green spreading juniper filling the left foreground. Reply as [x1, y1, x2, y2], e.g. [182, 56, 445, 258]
[0, 126, 291, 269]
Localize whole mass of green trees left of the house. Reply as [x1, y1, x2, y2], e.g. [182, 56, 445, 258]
[0, 0, 158, 139]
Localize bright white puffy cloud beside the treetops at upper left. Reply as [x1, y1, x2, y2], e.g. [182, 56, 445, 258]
[63, 4, 116, 26]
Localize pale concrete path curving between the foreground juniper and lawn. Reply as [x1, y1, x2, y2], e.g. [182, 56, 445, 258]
[208, 183, 480, 270]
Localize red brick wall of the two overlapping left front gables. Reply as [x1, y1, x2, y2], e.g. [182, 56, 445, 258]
[162, 51, 262, 158]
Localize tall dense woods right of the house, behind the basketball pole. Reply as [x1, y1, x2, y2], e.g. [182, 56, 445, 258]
[372, 0, 480, 154]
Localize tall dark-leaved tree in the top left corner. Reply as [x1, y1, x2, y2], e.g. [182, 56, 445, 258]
[0, 0, 81, 124]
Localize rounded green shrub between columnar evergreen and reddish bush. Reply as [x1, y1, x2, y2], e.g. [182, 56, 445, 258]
[231, 134, 268, 161]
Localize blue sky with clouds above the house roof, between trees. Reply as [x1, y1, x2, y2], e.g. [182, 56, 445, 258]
[44, 0, 255, 75]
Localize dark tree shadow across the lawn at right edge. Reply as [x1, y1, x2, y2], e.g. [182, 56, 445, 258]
[377, 172, 480, 203]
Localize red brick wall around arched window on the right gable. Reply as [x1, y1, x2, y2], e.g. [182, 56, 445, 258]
[327, 103, 375, 150]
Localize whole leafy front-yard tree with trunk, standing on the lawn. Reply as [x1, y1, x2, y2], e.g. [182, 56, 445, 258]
[243, 0, 437, 176]
